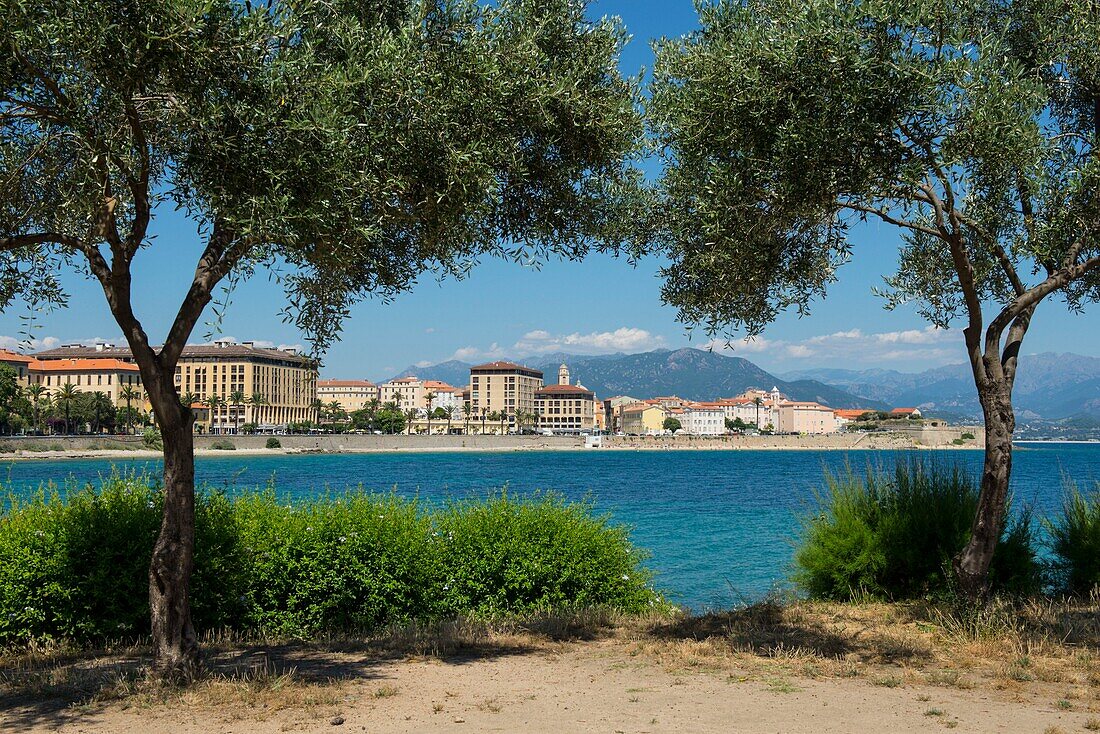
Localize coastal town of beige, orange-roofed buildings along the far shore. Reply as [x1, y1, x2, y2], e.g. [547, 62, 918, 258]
[0, 340, 922, 436]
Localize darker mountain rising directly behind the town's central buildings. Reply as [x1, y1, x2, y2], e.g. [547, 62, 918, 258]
[398, 349, 888, 409]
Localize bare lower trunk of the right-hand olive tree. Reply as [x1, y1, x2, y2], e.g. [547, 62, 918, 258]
[955, 384, 1016, 601]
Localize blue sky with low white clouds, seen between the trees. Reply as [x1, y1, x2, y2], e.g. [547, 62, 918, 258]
[0, 0, 1100, 380]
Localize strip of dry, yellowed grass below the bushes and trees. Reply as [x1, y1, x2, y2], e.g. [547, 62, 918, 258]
[0, 599, 1100, 717]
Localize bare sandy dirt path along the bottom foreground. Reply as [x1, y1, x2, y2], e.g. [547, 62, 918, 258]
[0, 639, 1097, 734]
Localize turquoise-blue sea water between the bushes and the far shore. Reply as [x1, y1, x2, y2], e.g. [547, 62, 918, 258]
[2, 445, 1100, 610]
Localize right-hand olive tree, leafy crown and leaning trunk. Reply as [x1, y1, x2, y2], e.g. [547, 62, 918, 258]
[650, 0, 1100, 598]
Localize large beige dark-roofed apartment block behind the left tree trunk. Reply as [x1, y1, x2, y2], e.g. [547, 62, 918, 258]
[35, 340, 317, 434]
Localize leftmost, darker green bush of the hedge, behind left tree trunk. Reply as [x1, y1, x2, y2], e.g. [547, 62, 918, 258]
[0, 474, 242, 644]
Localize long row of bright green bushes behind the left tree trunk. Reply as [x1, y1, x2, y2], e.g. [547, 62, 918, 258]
[0, 475, 661, 645]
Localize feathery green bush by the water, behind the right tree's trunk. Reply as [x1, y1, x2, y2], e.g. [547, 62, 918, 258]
[794, 458, 1040, 600]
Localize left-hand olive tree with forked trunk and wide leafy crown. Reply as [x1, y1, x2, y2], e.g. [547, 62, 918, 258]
[0, 0, 641, 676]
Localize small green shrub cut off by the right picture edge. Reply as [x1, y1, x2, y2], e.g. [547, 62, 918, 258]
[1045, 481, 1100, 594]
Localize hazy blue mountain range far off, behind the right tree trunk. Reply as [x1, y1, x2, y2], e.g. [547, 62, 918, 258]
[783, 352, 1100, 420]
